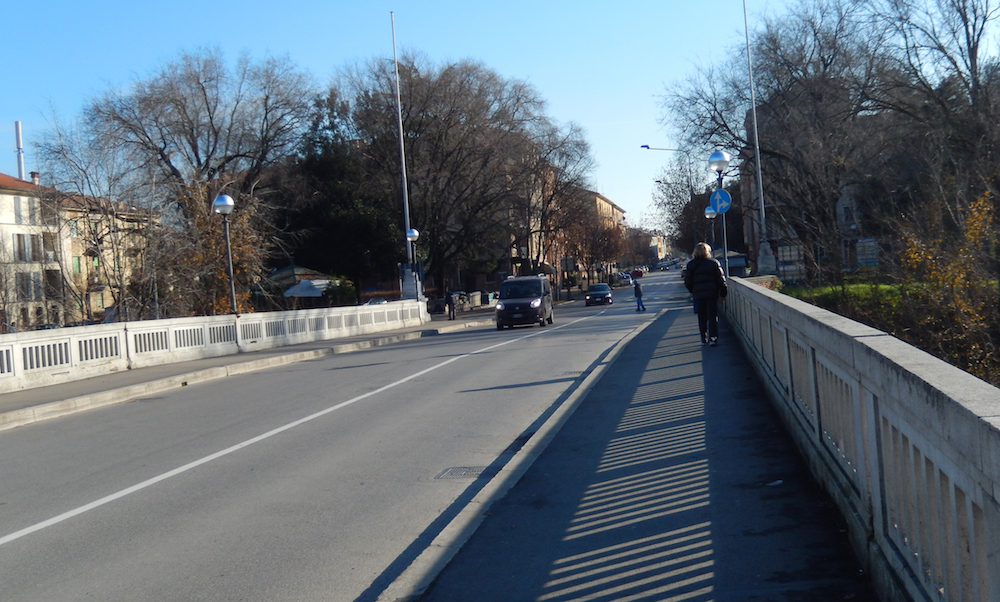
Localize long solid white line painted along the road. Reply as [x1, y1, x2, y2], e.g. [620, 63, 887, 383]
[0, 312, 604, 546]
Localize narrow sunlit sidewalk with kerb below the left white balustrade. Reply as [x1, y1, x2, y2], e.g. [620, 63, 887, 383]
[0, 308, 493, 430]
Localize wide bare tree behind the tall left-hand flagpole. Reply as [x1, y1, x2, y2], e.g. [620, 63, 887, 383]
[340, 55, 585, 292]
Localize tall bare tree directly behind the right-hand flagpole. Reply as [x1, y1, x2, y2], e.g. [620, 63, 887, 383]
[664, 0, 894, 280]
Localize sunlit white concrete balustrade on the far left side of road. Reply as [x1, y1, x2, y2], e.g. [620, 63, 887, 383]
[0, 301, 430, 393]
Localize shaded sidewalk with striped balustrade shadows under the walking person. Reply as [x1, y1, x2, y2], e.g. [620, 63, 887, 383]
[419, 295, 877, 602]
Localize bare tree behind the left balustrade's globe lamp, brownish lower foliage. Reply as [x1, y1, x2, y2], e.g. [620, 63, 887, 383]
[65, 50, 315, 315]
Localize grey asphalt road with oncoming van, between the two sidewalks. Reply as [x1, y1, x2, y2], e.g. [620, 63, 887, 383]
[0, 275, 666, 602]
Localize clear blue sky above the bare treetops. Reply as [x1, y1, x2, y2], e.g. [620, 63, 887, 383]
[0, 0, 784, 224]
